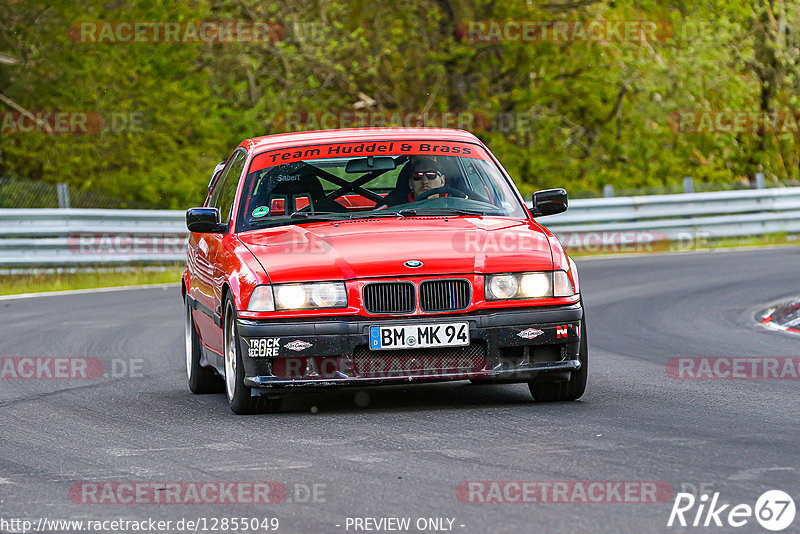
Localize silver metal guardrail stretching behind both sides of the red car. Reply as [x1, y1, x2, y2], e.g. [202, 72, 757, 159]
[0, 187, 800, 267]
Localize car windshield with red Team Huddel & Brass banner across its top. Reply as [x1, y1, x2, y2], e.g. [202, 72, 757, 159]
[237, 141, 527, 231]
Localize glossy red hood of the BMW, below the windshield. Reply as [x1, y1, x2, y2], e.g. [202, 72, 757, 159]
[238, 217, 553, 283]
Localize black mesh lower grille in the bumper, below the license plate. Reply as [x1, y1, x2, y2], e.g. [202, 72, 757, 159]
[353, 343, 486, 379]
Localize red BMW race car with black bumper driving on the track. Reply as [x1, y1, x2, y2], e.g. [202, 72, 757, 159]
[186, 128, 588, 414]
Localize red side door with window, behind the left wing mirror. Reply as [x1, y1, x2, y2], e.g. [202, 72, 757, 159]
[192, 149, 247, 355]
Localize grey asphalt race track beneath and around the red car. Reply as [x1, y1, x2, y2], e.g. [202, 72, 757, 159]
[0, 247, 800, 534]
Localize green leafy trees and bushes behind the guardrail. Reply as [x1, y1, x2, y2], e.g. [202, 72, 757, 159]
[0, 0, 800, 208]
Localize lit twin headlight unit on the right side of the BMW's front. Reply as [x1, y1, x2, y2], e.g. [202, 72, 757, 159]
[485, 271, 575, 300]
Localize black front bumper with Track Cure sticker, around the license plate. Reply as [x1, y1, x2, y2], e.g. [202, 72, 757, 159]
[236, 303, 583, 388]
